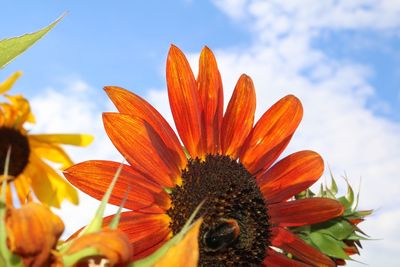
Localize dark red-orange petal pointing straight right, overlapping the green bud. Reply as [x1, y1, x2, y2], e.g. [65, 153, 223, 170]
[268, 198, 344, 227]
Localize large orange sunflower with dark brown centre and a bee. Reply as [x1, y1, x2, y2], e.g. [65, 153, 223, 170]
[65, 46, 343, 266]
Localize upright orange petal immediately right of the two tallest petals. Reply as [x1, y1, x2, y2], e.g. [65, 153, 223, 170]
[221, 74, 256, 158]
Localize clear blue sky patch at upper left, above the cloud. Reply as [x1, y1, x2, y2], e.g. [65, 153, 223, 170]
[0, 1, 249, 99]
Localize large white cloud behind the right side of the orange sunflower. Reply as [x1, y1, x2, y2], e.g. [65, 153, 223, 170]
[142, 0, 400, 266]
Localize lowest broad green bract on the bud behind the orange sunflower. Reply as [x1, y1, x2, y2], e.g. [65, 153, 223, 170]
[310, 233, 350, 260]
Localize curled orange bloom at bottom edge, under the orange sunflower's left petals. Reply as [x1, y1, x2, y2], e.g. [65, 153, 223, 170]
[67, 228, 133, 266]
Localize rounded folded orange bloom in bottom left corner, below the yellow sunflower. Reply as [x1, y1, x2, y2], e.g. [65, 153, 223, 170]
[6, 202, 64, 267]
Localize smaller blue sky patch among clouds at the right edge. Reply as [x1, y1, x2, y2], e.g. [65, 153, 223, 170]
[315, 30, 400, 121]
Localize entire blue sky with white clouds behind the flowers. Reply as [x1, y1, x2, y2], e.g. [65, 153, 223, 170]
[0, 0, 400, 267]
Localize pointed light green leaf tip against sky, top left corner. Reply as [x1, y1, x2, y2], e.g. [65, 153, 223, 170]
[0, 15, 64, 68]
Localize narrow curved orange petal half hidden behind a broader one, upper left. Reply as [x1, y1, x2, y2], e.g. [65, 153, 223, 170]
[104, 86, 187, 169]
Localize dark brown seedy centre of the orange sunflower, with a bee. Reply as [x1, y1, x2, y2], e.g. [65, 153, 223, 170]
[167, 155, 270, 266]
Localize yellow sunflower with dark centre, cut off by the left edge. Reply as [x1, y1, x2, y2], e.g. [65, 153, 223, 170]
[0, 72, 93, 207]
